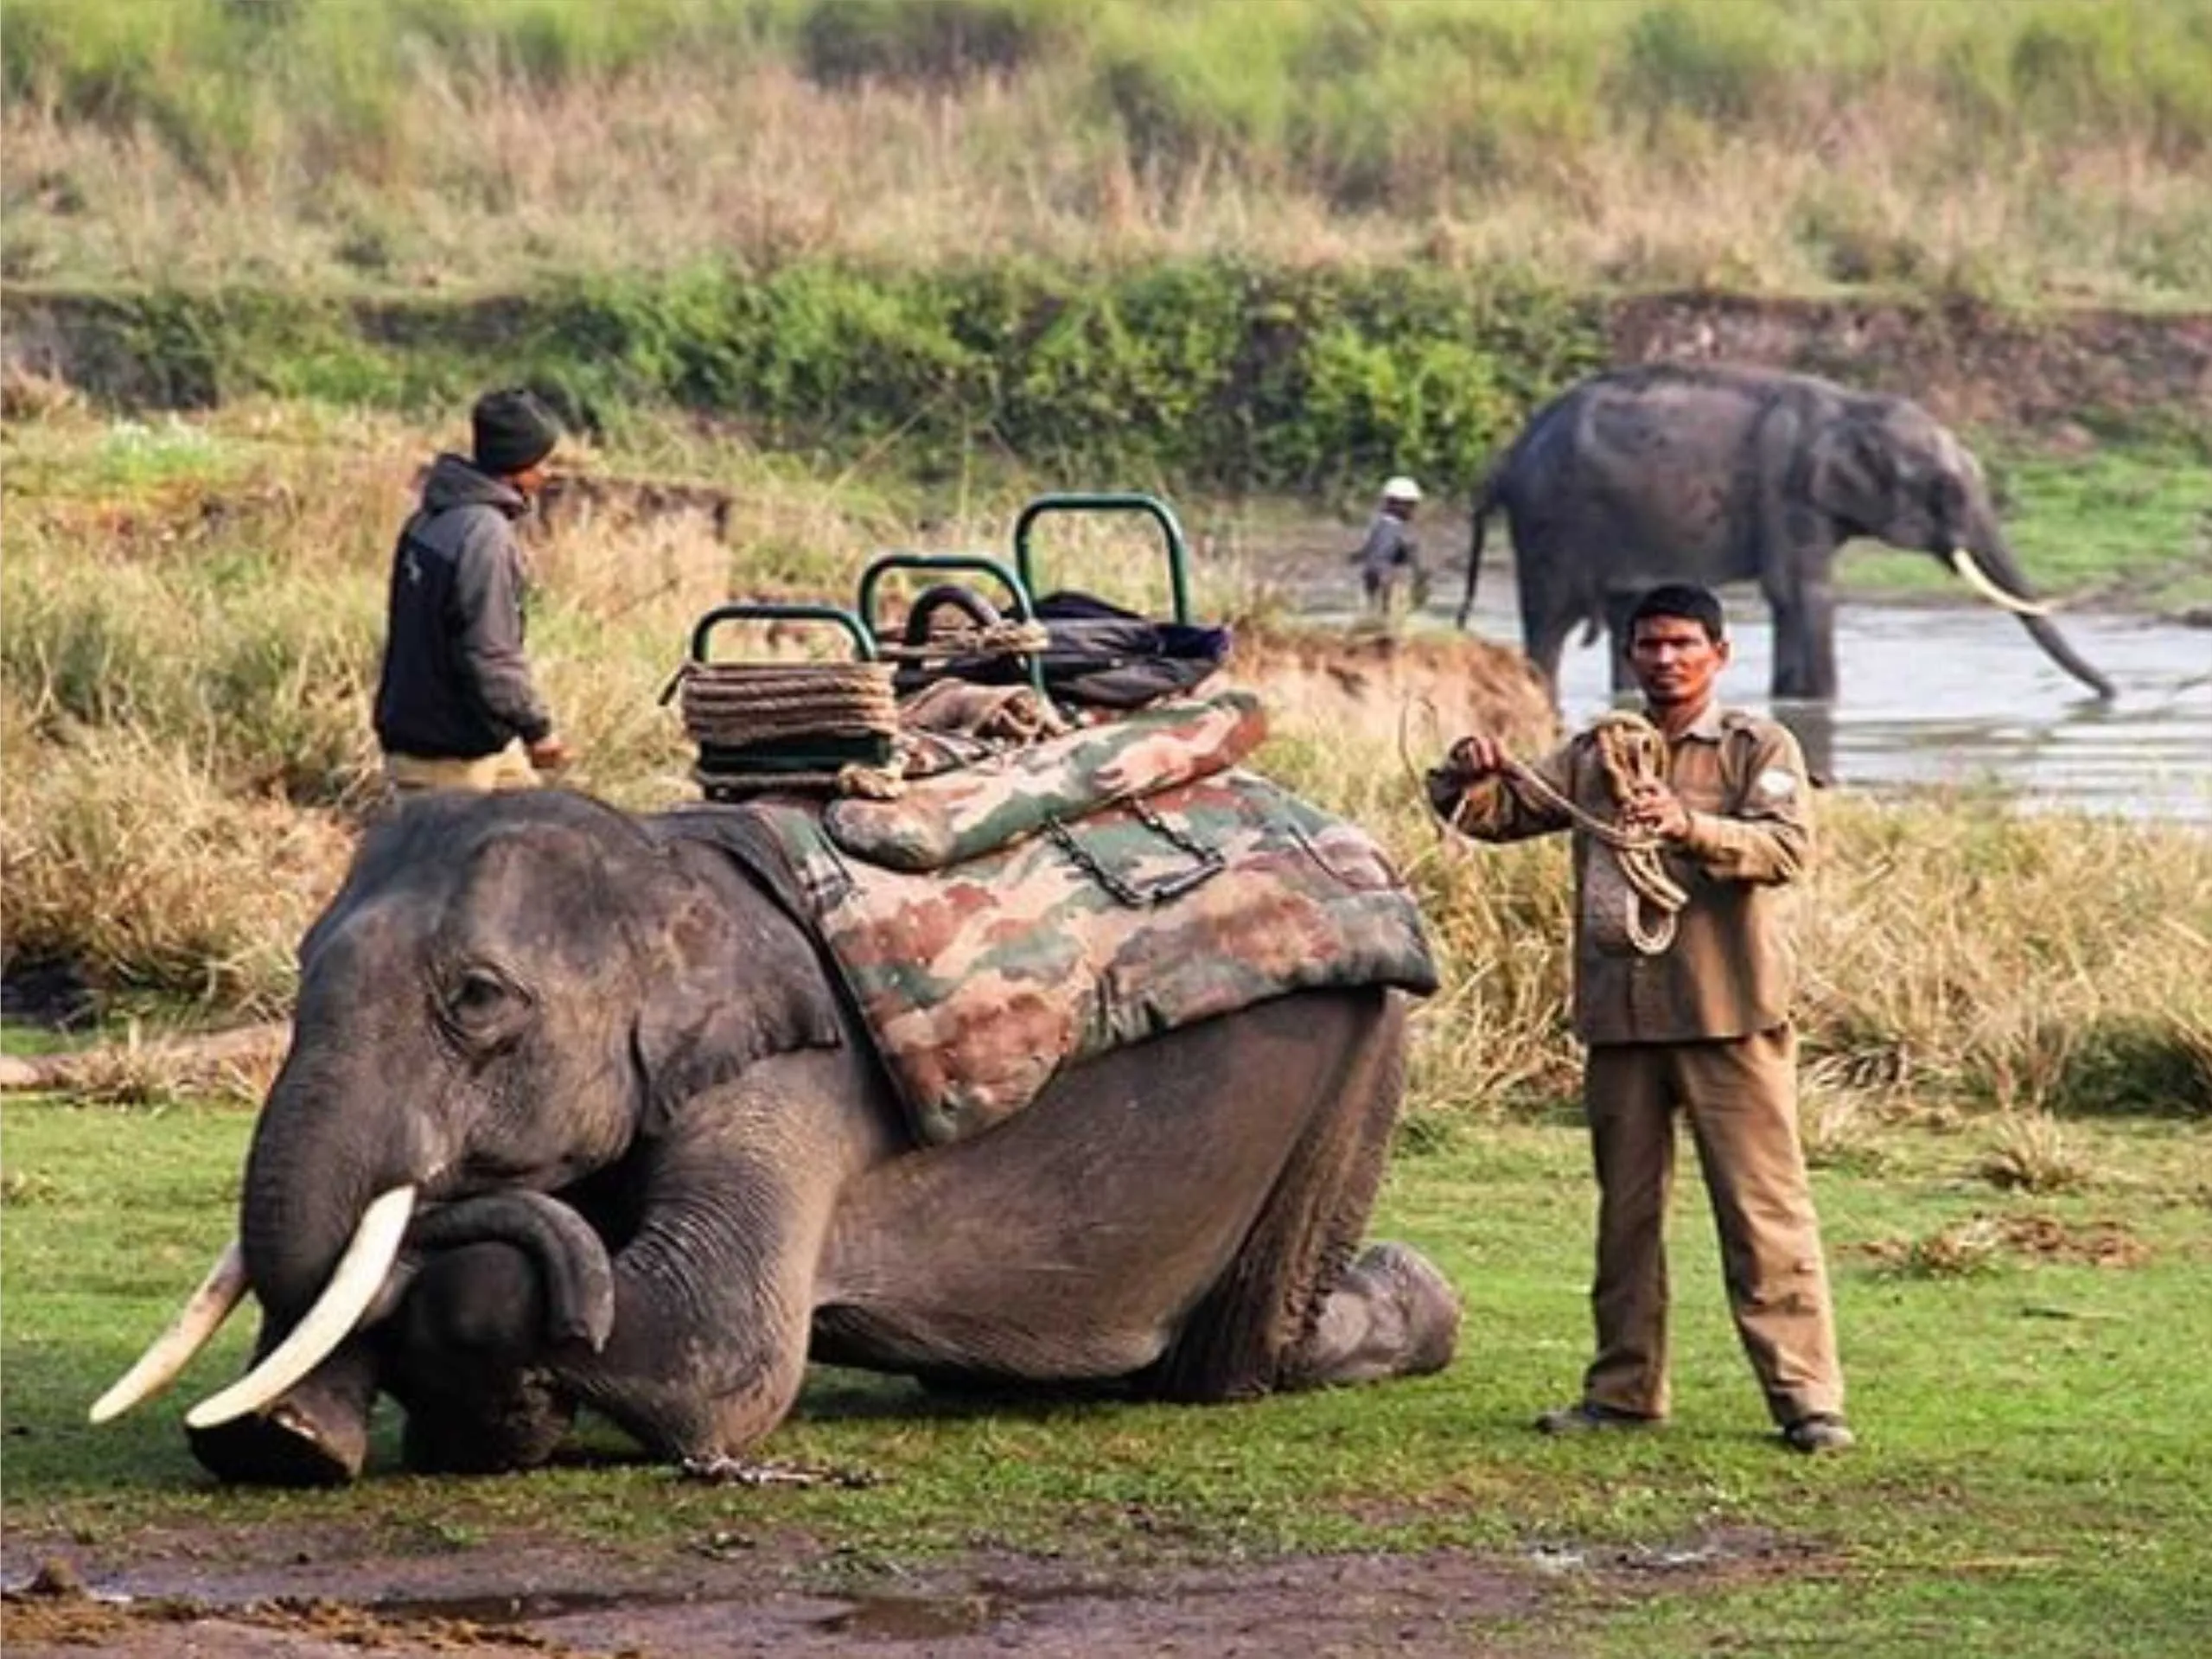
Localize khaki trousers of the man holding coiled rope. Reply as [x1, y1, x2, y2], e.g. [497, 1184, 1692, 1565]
[1582, 1026, 1843, 1425]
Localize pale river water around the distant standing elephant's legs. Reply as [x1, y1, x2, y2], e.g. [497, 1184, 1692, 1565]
[1450, 573, 2212, 825]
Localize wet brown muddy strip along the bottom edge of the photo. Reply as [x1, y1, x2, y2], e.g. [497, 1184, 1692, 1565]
[4, 1528, 1820, 1659]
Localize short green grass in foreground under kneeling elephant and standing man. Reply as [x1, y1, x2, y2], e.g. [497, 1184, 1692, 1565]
[0, 1101, 2212, 1655]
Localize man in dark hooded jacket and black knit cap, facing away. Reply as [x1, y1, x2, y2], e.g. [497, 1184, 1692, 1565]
[376, 392, 569, 792]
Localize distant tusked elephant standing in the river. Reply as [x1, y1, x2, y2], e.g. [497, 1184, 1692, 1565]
[1460, 363, 2113, 701]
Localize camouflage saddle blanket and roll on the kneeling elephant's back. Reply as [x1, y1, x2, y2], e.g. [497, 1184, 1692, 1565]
[666, 692, 1436, 1144]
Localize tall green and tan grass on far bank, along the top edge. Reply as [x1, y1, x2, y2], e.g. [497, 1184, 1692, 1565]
[0, 0, 2212, 301]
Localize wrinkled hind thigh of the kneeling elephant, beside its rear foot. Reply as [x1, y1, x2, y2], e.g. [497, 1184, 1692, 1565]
[1144, 993, 1449, 1401]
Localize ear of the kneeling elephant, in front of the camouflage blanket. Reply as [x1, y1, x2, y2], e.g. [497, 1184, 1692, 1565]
[630, 849, 843, 1133]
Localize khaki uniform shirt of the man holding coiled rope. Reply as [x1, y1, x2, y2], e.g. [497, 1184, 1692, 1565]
[1429, 701, 1814, 1044]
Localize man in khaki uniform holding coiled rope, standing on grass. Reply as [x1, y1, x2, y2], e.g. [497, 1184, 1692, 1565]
[1429, 584, 1852, 1451]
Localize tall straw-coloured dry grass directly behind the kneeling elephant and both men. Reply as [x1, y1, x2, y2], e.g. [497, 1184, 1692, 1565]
[0, 405, 2212, 1133]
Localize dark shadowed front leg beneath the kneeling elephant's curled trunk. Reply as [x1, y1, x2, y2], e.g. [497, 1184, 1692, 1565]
[380, 1243, 575, 1473]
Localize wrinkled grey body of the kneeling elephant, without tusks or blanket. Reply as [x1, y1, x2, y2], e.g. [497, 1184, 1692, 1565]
[102, 789, 1457, 1482]
